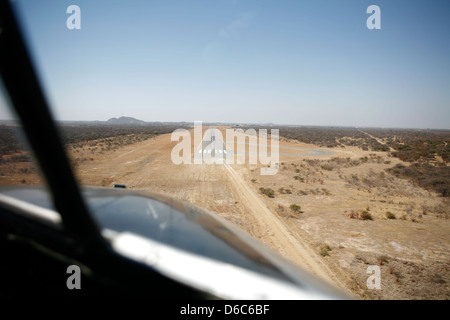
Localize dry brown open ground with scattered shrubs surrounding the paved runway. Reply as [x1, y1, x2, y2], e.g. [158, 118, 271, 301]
[0, 128, 450, 299]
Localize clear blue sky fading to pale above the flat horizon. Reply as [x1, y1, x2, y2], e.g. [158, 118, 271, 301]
[0, 0, 450, 129]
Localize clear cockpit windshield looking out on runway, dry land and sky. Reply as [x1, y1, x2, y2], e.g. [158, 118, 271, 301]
[4, 0, 450, 299]
